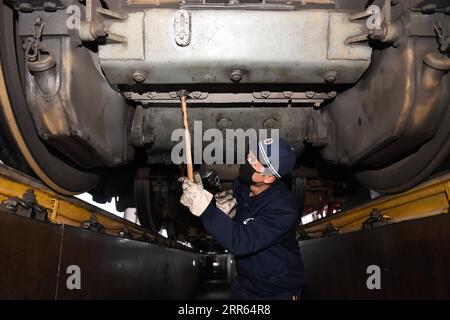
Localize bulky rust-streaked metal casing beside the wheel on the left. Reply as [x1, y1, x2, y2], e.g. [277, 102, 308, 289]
[19, 21, 133, 167]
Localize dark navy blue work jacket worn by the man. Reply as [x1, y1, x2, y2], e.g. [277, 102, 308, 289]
[200, 180, 305, 299]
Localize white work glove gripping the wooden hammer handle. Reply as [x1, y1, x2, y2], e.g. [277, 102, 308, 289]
[178, 173, 213, 217]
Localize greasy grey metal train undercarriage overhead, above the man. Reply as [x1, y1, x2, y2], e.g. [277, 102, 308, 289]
[0, 0, 450, 234]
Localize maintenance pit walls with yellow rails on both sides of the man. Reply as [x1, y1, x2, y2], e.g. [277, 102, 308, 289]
[0, 165, 450, 300]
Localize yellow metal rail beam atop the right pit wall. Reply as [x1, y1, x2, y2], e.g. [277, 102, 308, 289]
[300, 173, 450, 237]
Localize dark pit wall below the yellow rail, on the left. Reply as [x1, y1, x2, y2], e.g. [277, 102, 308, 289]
[0, 212, 200, 299]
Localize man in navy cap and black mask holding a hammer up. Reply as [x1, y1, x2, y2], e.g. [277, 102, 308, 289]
[180, 138, 305, 300]
